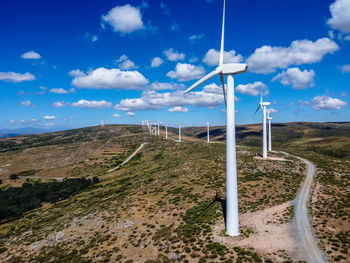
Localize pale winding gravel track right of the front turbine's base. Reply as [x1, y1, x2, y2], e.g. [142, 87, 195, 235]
[281, 152, 328, 263]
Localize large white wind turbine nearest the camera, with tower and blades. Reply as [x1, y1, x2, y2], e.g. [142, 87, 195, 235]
[185, 0, 247, 236]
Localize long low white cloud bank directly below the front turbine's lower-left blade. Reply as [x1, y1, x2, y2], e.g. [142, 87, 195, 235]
[115, 84, 224, 111]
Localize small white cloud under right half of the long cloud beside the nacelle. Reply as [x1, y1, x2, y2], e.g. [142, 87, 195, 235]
[272, 68, 315, 89]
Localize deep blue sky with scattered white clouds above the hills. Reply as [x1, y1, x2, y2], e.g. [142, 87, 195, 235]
[0, 0, 350, 129]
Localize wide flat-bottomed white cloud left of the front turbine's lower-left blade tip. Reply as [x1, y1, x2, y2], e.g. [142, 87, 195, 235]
[69, 67, 148, 90]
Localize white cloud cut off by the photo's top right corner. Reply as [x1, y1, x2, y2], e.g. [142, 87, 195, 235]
[327, 0, 350, 34]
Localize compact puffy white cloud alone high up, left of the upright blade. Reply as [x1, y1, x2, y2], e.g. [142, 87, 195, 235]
[102, 4, 144, 34]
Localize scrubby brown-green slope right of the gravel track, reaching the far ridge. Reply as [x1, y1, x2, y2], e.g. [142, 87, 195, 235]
[184, 122, 350, 262]
